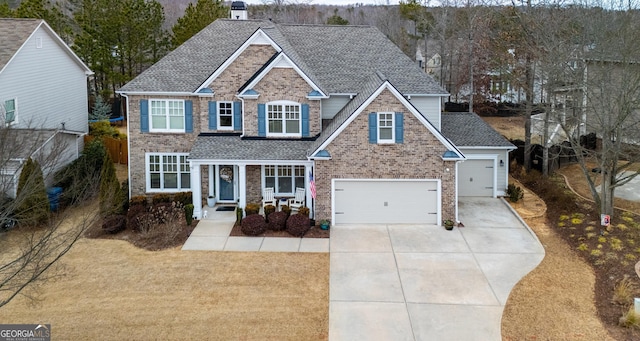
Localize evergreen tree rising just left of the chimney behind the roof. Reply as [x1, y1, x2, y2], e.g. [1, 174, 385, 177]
[171, 0, 229, 48]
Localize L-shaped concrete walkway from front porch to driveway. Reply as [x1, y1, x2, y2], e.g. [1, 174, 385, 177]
[182, 208, 329, 252]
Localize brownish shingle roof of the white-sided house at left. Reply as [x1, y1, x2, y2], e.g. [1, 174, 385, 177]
[0, 18, 42, 70]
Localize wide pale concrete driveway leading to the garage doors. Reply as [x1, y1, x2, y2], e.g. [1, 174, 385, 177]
[329, 198, 544, 341]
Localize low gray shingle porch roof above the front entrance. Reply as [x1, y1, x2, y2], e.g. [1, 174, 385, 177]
[189, 135, 313, 161]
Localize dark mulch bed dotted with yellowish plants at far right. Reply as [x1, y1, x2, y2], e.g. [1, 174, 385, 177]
[512, 168, 640, 340]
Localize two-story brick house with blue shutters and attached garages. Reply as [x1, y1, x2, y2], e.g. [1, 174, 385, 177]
[118, 14, 514, 225]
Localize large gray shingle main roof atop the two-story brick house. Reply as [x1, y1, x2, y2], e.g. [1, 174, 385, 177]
[120, 19, 446, 94]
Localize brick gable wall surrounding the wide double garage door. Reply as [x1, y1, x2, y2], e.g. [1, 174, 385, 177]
[315, 90, 456, 219]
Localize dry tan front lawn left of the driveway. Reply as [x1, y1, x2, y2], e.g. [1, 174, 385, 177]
[0, 203, 329, 340]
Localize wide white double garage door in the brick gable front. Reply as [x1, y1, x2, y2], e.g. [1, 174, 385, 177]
[333, 179, 440, 224]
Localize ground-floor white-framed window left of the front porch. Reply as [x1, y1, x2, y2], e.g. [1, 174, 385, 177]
[147, 153, 191, 192]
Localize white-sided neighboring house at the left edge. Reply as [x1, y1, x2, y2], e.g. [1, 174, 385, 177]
[0, 18, 92, 197]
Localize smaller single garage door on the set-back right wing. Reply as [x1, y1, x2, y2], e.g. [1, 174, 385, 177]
[458, 160, 495, 197]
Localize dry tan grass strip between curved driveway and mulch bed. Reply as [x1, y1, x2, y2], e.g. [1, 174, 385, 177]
[502, 179, 613, 341]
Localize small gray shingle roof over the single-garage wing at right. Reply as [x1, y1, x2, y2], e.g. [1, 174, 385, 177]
[441, 112, 515, 148]
